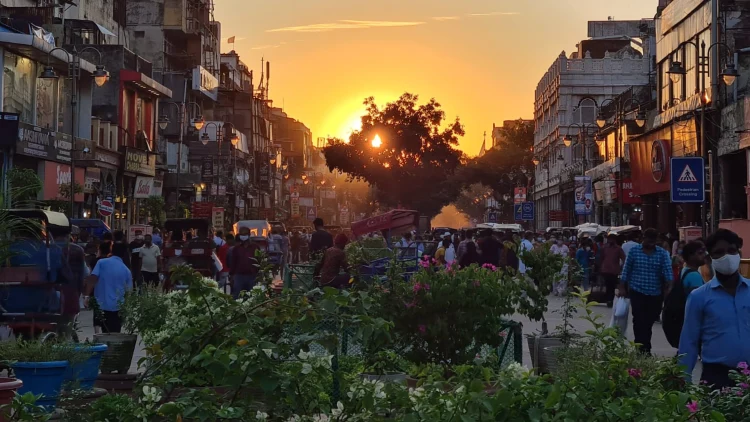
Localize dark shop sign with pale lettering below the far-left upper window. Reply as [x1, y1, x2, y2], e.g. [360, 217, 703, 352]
[16, 122, 73, 163]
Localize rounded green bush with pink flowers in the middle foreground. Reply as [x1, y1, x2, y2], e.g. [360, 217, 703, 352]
[378, 266, 529, 366]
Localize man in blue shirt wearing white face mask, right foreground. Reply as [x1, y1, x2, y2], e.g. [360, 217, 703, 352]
[679, 229, 750, 389]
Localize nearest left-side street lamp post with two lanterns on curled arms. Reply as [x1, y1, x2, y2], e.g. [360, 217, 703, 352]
[39, 47, 109, 218]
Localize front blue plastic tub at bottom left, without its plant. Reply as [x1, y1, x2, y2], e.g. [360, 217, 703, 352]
[10, 360, 68, 408]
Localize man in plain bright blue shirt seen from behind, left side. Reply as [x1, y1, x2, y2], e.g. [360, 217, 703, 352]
[85, 243, 133, 333]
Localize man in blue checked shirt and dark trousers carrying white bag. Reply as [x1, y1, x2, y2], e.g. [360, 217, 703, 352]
[618, 229, 672, 354]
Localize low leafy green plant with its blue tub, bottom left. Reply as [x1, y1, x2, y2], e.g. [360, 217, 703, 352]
[0, 340, 90, 408]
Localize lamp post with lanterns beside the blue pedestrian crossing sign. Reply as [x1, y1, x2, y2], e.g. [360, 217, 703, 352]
[667, 41, 739, 239]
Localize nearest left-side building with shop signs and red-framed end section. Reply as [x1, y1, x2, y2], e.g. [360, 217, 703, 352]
[0, 0, 171, 228]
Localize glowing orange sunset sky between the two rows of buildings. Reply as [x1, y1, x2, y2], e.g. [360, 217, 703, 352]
[214, 0, 657, 155]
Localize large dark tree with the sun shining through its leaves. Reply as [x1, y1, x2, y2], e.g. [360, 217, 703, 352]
[323, 93, 464, 216]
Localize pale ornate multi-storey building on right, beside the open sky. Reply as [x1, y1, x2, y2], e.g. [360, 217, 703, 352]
[533, 20, 653, 227]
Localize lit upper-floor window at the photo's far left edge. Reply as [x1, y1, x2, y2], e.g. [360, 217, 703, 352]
[3, 51, 36, 123]
